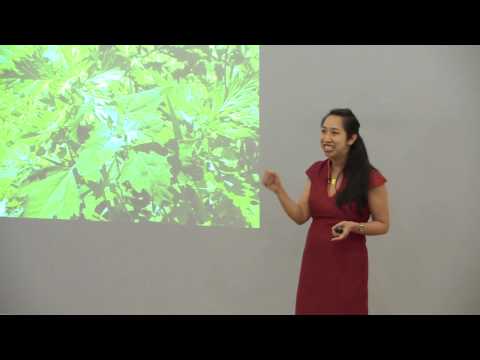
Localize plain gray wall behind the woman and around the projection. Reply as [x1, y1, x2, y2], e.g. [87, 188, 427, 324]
[0, 46, 480, 314]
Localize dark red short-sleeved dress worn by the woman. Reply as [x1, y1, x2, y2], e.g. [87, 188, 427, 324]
[295, 159, 386, 315]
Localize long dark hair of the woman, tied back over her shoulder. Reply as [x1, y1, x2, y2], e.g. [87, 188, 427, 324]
[322, 109, 375, 209]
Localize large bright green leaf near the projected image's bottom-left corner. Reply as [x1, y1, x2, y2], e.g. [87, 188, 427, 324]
[20, 170, 80, 219]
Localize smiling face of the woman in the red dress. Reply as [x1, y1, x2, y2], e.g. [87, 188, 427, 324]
[320, 115, 357, 159]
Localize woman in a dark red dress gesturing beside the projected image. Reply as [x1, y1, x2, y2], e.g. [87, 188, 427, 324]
[262, 109, 389, 314]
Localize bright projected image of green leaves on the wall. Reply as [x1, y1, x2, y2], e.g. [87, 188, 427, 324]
[0, 45, 260, 228]
